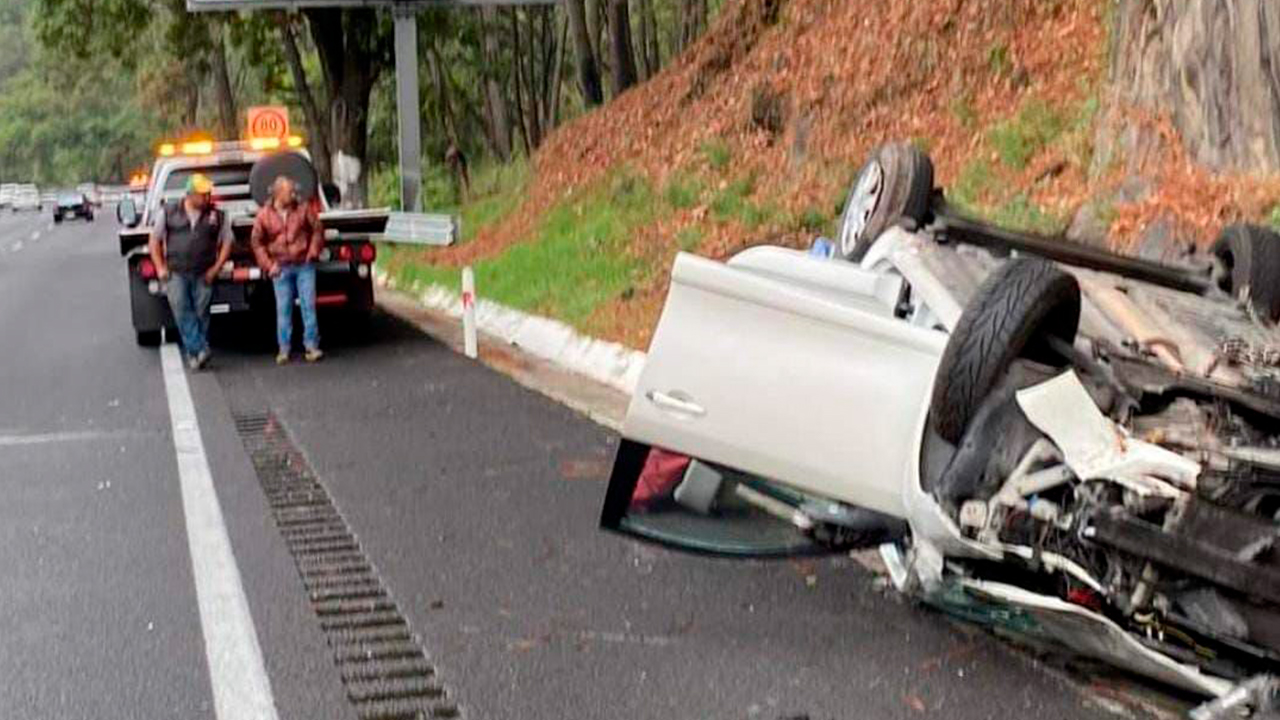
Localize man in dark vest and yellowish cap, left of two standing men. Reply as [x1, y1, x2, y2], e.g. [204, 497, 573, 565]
[150, 173, 233, 370]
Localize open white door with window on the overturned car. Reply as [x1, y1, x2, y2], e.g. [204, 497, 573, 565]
[603, 247, 946, 552]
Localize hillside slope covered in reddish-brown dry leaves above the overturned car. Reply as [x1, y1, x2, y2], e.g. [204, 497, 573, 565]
[414, 0, 1262, 347]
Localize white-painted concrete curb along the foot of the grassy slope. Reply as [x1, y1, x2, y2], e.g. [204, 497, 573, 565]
[374, 269, 645, 396]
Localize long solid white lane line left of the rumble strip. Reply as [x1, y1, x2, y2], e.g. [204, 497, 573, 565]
[160, 345, 278, 720]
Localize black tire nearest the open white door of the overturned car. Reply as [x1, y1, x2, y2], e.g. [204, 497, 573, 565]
[929, 258, 1080, 445]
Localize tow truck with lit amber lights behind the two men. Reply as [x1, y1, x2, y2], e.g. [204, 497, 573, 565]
[116, 136, 390, 346]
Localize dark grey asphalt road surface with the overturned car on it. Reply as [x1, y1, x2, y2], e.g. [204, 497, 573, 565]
[0, 213, 1107, 720]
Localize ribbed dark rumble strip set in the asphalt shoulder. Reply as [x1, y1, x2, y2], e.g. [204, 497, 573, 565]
[236, 414, 460, 720]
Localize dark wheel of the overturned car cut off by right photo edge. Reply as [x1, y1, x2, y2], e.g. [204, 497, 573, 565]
[1210, 224, 1280, 323]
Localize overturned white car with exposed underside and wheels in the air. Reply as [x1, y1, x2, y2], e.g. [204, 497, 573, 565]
[602, 145, 1280, 717]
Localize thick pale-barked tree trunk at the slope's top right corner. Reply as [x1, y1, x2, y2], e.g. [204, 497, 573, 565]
[1111, 0, 1280, 172]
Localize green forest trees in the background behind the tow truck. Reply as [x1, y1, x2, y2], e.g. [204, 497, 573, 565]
[0, 0, 718, 192]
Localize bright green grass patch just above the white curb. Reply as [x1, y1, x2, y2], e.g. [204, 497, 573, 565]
[390, 172, 650, 331]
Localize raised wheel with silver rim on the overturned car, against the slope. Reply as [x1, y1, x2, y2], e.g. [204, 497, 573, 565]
[836, 142, 933, 263]
